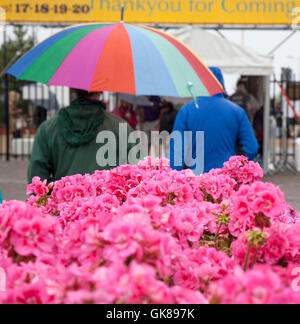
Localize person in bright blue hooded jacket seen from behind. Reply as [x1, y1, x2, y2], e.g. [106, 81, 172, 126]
[170, 68, 259, 175]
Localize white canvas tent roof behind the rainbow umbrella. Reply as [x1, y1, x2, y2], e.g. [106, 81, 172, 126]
[169, 26, 274, 76]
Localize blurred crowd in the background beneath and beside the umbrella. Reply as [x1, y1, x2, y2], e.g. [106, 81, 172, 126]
[0, 77, 300, 161]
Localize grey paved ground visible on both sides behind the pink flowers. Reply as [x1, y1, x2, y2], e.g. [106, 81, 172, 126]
[0, 160, 300, 211]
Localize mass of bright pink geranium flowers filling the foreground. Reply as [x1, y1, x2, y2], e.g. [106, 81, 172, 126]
[0, 157, 300, 304]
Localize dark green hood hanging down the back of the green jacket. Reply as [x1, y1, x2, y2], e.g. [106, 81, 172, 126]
[57, 99, 104, 147]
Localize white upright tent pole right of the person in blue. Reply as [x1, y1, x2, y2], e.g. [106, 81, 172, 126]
[263, 76, 271, 174]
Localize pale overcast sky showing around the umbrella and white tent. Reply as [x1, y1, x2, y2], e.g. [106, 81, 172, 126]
[0, 26, 300, 93]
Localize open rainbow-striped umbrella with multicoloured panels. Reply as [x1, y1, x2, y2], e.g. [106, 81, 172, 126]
[7, 23, 224, 97]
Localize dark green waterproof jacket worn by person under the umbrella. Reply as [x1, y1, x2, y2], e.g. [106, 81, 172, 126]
[28, 99, 132, 183]
